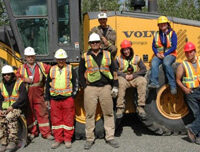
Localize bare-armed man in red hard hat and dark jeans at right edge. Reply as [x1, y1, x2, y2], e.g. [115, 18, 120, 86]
[176, 42, 200, 145]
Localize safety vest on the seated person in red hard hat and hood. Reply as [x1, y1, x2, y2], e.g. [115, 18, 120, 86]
[117, 55, 140, 73]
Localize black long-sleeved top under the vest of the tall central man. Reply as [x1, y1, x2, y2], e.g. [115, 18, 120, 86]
[79, 50, 118, 88]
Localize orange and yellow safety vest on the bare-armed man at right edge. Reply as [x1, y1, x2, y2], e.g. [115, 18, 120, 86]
[182, 57, 200, 88]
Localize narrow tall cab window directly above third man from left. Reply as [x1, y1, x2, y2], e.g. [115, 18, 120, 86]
[57, 0, 71, 44]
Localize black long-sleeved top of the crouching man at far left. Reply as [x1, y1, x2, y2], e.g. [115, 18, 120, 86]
[0, 80, 28, 110]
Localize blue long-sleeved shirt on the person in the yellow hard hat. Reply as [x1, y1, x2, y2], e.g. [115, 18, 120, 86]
[152, 29, 177, 56]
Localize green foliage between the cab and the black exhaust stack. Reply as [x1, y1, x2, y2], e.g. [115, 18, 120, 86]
[82, 0, 120, 13]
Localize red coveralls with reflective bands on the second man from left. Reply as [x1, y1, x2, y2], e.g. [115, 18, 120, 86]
[16, 62, 51, 138]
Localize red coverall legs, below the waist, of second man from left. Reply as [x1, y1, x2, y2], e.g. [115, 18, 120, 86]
[27, 87, 51, 138]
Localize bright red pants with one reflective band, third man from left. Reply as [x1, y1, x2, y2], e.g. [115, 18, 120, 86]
[51, 97, 75, 143]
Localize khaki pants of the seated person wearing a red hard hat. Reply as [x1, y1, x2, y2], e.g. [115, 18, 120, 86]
[117, 76, 147, 109]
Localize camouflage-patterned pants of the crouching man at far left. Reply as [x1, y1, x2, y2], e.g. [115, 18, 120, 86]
[0, 109, 21, 145]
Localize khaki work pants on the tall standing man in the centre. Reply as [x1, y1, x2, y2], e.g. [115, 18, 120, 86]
[84, 85, 115, 141]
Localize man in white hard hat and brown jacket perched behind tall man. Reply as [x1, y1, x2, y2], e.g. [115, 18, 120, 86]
[90, 12, 117, 57]
